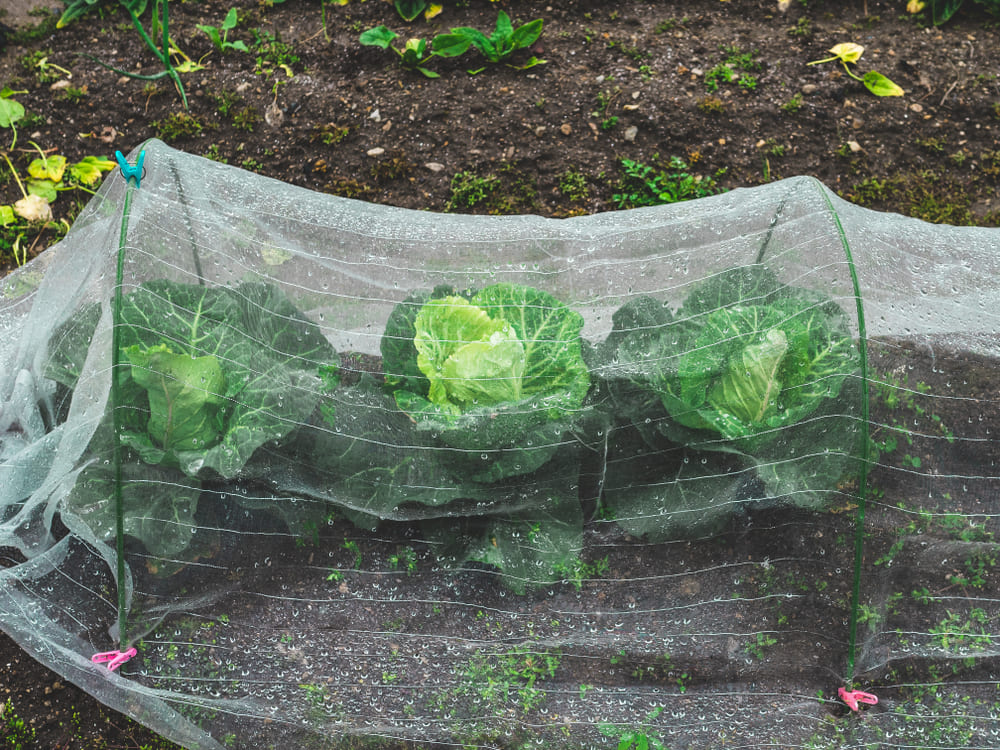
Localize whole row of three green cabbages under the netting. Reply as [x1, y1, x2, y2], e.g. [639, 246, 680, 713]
[47, 265, 862, 590]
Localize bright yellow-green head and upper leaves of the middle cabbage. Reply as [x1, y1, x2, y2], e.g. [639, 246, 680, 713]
[382, 284, 590, 481]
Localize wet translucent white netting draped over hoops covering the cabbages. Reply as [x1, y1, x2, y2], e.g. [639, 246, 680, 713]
[0, 141, 1000, 750]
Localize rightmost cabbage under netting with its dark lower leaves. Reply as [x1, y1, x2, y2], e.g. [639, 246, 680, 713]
[598, 265, 861, 538]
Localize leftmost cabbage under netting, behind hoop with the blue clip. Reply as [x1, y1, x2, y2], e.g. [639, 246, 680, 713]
[45, 280, 336, 557]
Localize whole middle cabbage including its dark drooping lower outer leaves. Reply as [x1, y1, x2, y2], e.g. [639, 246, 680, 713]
[313, 284, 591, 591]
